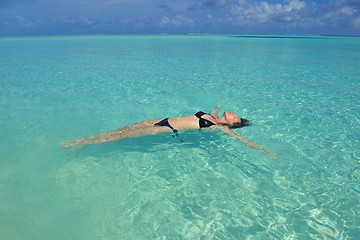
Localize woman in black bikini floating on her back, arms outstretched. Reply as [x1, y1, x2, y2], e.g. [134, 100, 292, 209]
[63, 106, 264, 150]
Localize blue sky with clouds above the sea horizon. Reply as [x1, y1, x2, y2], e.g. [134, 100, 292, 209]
[0, 0, 360, 36]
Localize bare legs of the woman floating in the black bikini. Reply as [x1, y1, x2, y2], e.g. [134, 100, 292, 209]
[62, 120, 172, 147]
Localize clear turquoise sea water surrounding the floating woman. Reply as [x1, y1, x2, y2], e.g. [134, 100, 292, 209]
[0, 35, 360, 239]
